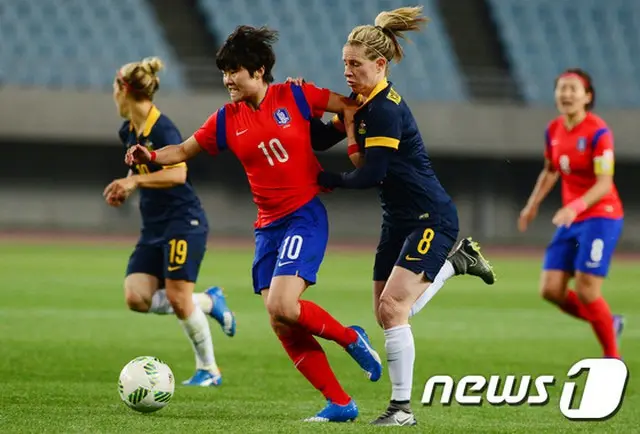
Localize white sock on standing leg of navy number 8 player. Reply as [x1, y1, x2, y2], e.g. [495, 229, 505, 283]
[384, 324, 416, 401]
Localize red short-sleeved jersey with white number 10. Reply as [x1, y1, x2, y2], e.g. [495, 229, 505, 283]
[194, 84, 330, 228]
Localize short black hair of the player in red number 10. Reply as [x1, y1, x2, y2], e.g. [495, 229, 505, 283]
[216, 26, 278, 83]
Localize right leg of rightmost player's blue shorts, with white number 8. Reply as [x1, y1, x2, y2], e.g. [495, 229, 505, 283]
[575, 218, 622, 277]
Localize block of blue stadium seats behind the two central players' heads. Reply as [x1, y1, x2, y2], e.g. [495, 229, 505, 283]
[199, 0, 467, 101]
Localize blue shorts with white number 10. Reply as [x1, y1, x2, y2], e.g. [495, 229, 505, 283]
[252, 197, 329, 294]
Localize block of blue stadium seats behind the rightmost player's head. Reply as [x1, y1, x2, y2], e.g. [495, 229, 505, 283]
[489, 0, 640, 107]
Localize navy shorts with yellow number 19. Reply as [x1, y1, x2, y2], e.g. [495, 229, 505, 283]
[127, 231, 207, 282]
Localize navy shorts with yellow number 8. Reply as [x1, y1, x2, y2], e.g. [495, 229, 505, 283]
[373, 224, 458, 282]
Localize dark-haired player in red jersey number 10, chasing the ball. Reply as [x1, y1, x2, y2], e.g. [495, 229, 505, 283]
[126, 26, 382, 422]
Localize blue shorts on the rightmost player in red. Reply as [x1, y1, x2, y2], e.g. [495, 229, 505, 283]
[543, 218, 623, 277]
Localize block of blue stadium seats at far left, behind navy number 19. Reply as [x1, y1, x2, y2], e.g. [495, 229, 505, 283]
[0, 0, 186, 89]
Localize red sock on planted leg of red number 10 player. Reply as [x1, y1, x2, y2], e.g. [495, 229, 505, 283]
[278, 327, 351, 405]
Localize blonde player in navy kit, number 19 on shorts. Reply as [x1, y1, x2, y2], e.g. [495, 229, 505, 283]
[104, 57, 235, 386]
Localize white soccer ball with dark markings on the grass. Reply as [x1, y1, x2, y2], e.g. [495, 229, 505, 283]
[118, 356, 175, 413]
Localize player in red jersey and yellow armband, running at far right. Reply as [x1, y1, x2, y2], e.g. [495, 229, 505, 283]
[518, 69, 623, 358]
